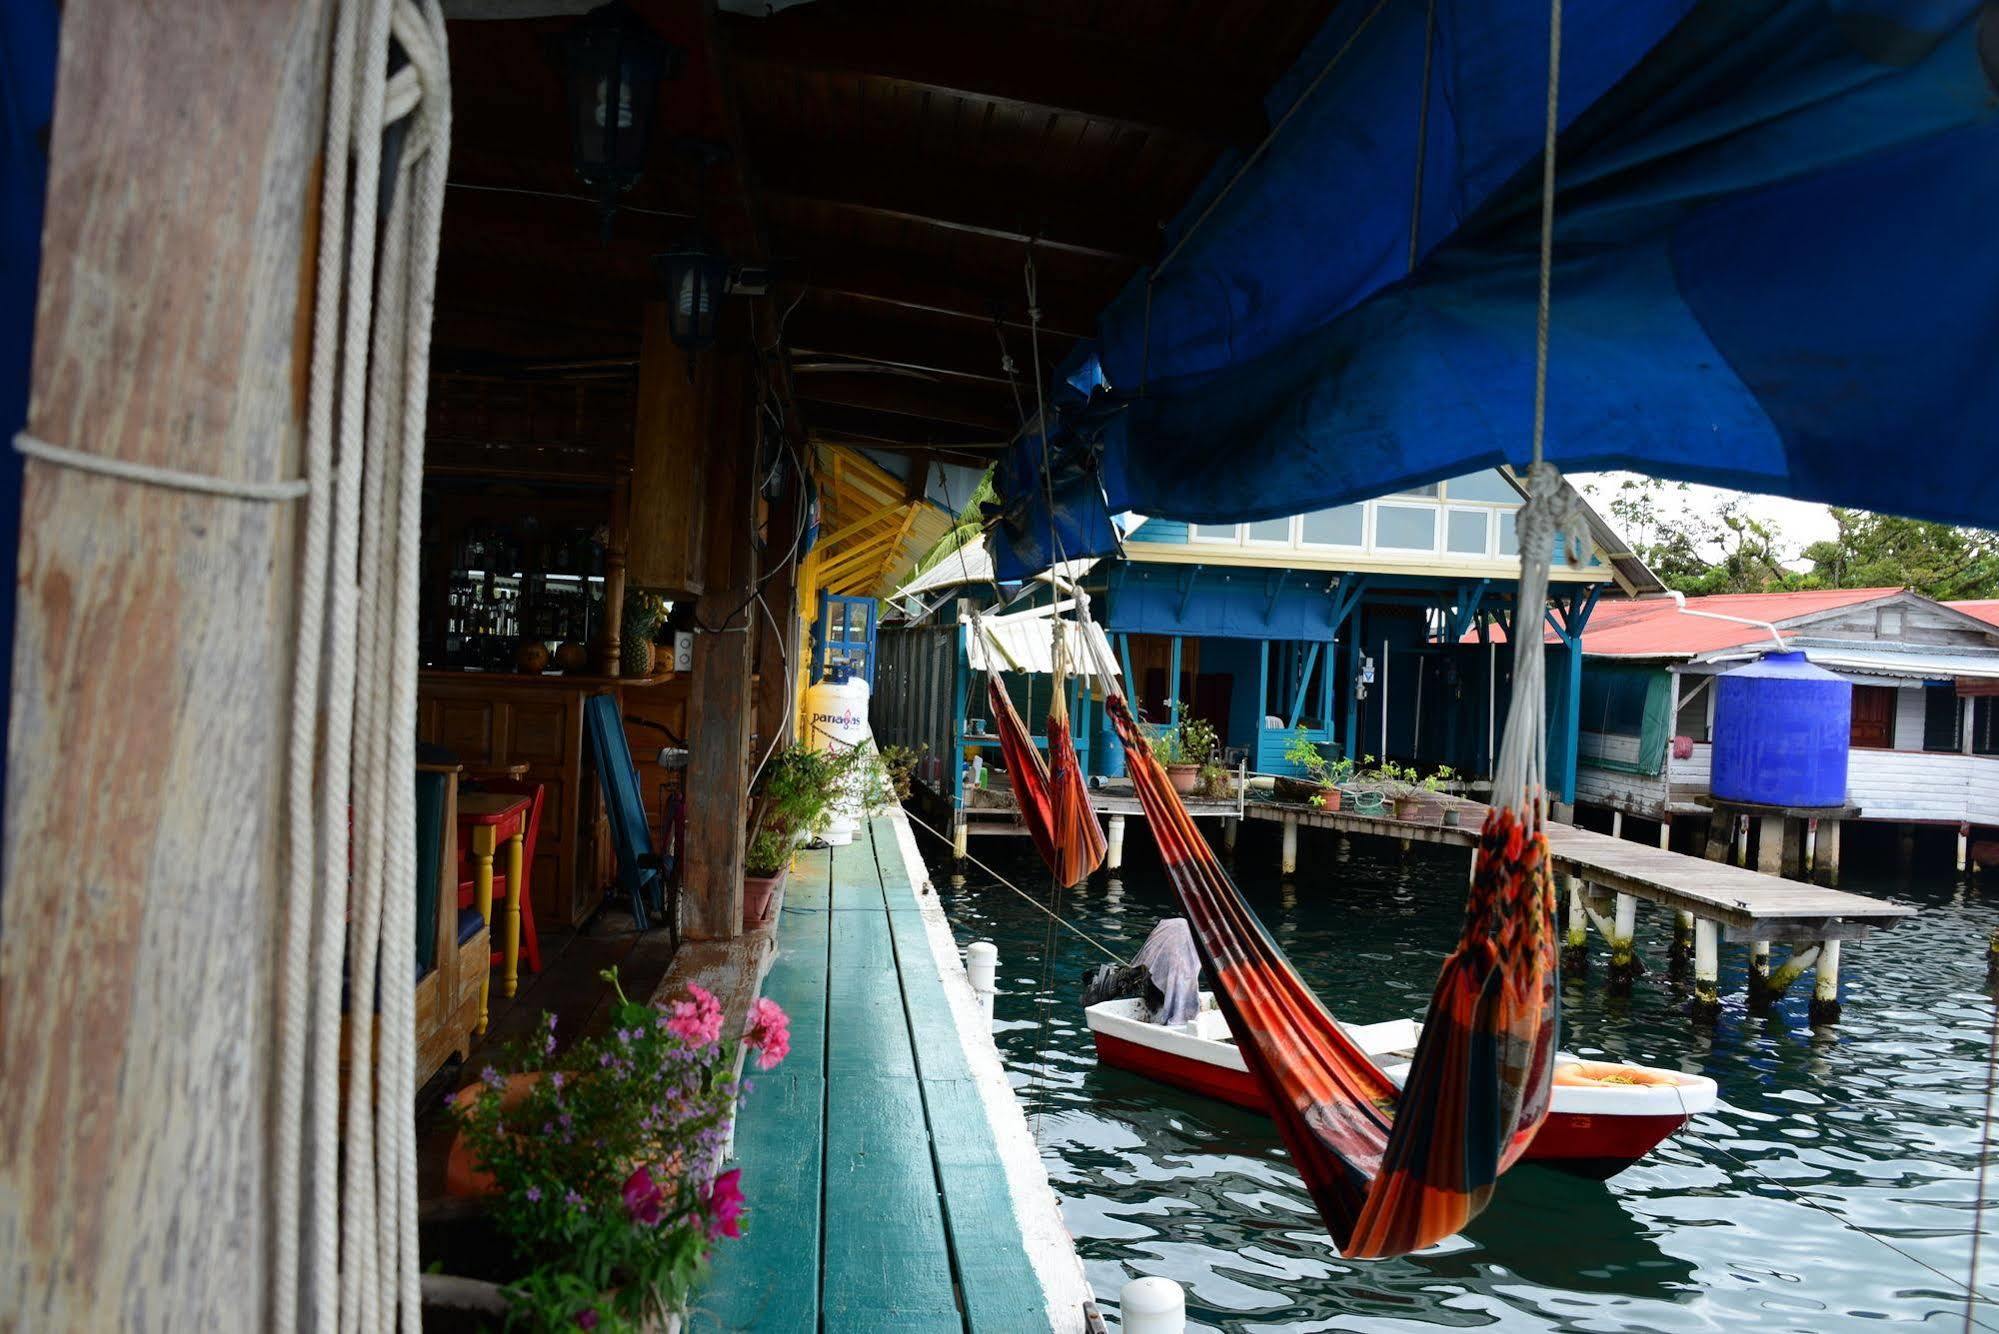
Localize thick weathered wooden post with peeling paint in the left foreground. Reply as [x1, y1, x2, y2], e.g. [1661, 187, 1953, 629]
[0, 0, 325, 1330]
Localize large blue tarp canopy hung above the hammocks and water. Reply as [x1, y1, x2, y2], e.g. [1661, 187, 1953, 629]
[992, 0, 1999, 578]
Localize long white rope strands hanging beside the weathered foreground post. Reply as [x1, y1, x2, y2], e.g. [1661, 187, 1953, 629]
[272, 0, 450, 1330]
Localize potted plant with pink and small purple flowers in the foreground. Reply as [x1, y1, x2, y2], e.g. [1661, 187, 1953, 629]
[452, 970, 792, 1334]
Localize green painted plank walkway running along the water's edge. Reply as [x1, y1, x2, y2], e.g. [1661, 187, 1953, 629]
[692, 820, 1049, 1334]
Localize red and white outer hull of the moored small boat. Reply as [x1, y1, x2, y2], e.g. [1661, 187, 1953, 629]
[1087, 1000, 1715, 1180]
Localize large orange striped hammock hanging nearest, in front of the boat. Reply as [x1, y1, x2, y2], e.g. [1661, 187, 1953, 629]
[1105, 694, 1555, 1258]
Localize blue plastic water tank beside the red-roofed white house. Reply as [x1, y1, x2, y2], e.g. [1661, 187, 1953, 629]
[1709, 652, 1853, 806]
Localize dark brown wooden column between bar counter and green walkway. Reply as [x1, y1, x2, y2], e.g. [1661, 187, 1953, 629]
[683, 350, 758, 940]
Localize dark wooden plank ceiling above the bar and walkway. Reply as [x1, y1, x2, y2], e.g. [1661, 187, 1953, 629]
[436, 0, 1335, 576]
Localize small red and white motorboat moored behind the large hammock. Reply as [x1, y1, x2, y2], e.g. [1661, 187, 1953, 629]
[1085, 992, 1715, 1180]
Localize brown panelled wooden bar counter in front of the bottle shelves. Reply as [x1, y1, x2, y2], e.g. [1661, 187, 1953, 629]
[416, 668, 688, 928]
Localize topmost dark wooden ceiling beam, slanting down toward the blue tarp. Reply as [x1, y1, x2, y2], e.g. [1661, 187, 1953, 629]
[726, 4, 1267, 148]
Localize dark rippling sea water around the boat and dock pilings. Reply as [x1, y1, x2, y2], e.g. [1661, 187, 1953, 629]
[926, 820, 1999, 1334]
